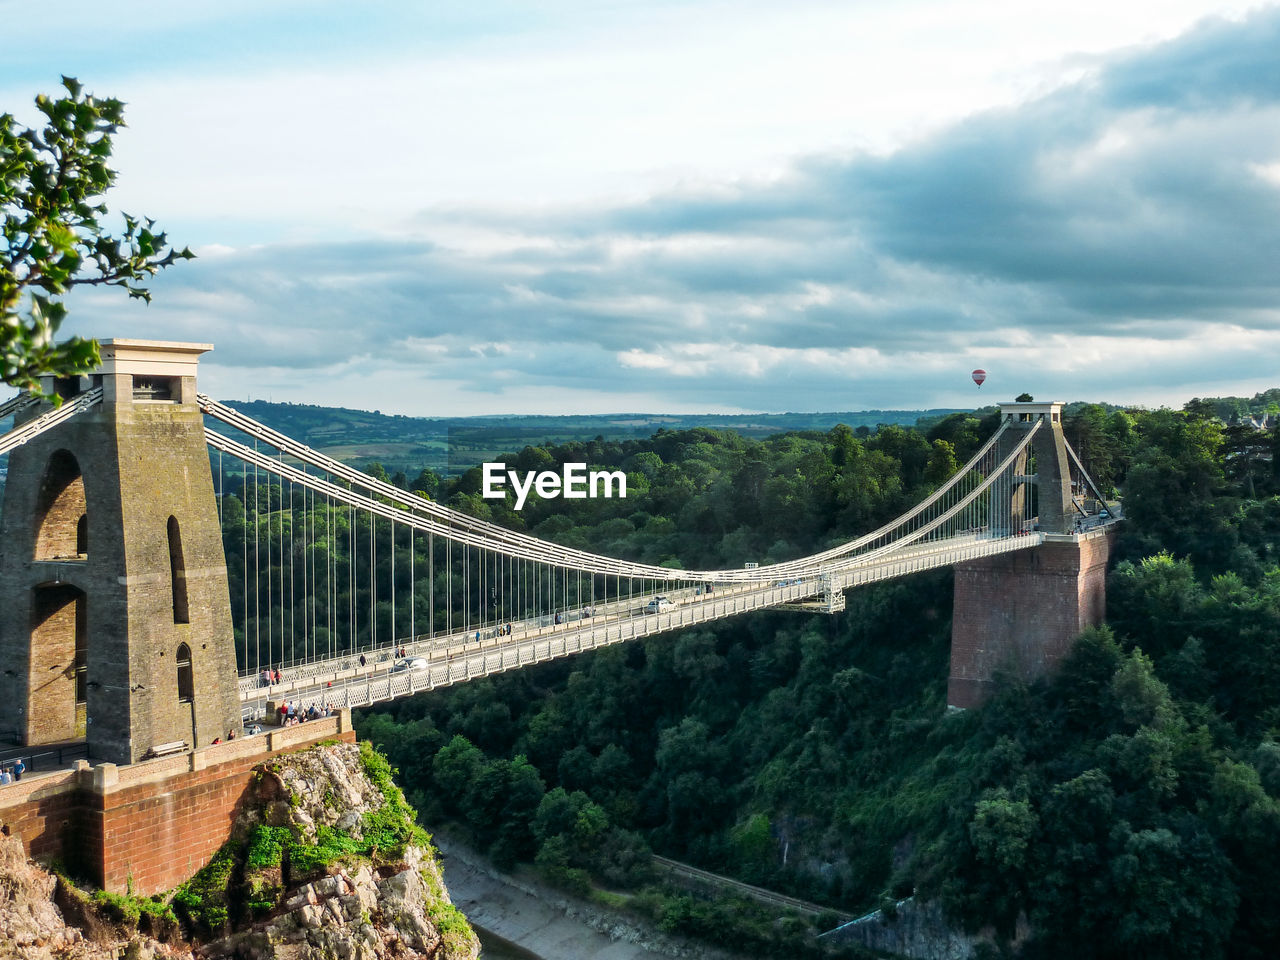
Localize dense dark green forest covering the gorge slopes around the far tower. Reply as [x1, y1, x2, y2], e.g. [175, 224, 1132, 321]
[228, 402, 1280, 957]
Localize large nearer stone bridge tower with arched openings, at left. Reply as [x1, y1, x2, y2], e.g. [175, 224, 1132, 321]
[0, 339, 241, 764]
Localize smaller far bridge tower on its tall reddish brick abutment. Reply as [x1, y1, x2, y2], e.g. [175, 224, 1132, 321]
[947, 402, 1115, 708]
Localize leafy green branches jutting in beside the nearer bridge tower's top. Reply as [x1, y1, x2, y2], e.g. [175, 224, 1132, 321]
[0, 77, 195, 390]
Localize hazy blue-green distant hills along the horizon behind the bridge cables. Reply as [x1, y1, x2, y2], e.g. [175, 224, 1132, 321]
[204, 401, 956, 475]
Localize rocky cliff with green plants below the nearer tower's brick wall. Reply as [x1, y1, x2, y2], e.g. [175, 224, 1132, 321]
[0, 744, 479, 960]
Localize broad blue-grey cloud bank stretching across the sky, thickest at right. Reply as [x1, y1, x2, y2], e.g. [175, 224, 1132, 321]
[64, 8, 1280, 408]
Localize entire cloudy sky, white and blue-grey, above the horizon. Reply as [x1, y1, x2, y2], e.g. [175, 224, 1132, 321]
[0, 0, 1280, 416]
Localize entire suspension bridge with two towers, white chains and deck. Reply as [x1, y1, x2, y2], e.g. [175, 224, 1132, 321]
[0, 340, 1117, 763]
